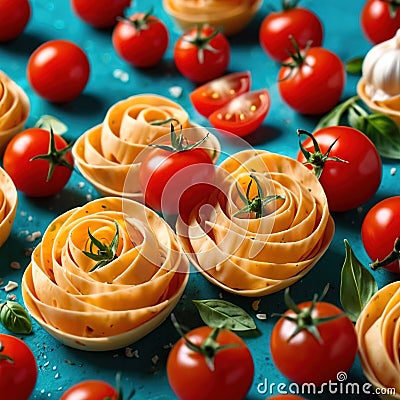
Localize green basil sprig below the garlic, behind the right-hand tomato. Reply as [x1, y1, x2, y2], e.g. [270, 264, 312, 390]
[315, 96, 400, 159]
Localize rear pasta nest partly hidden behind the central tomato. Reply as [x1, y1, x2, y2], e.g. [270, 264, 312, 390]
[72, 94, 219, 201]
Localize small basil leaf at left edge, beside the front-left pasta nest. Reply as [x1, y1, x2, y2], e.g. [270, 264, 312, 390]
[0, 301, 32, 334]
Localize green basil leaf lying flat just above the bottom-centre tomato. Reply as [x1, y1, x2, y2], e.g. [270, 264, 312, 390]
[193, 300, 256, 331]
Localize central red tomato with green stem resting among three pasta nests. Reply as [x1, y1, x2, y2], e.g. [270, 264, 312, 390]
[139, 125, 215, 217]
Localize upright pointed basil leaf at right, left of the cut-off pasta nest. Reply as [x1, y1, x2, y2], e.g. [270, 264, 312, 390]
[340, 239, 378, 322]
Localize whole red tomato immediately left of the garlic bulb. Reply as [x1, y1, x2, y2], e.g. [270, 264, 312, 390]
[278, 47, 346, 115]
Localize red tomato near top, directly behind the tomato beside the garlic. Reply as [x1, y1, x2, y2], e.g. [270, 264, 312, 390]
[259, 6, 323, 61]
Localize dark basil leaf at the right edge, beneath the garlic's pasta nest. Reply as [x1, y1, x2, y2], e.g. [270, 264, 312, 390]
[361, 113, 400, 159]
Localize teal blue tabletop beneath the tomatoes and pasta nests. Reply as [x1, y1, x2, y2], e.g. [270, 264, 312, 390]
[0, 0, 400, 400]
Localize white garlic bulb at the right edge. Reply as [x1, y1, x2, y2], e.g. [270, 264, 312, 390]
[362, 29, 400, 101]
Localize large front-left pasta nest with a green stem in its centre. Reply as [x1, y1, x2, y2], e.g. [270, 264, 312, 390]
[22, 197, 189, 348]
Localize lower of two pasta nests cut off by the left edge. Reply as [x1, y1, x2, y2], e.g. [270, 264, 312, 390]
[0, 168, 18, 246]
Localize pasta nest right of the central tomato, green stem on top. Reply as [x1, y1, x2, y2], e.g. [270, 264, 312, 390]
[177, 150, 334, 296]
